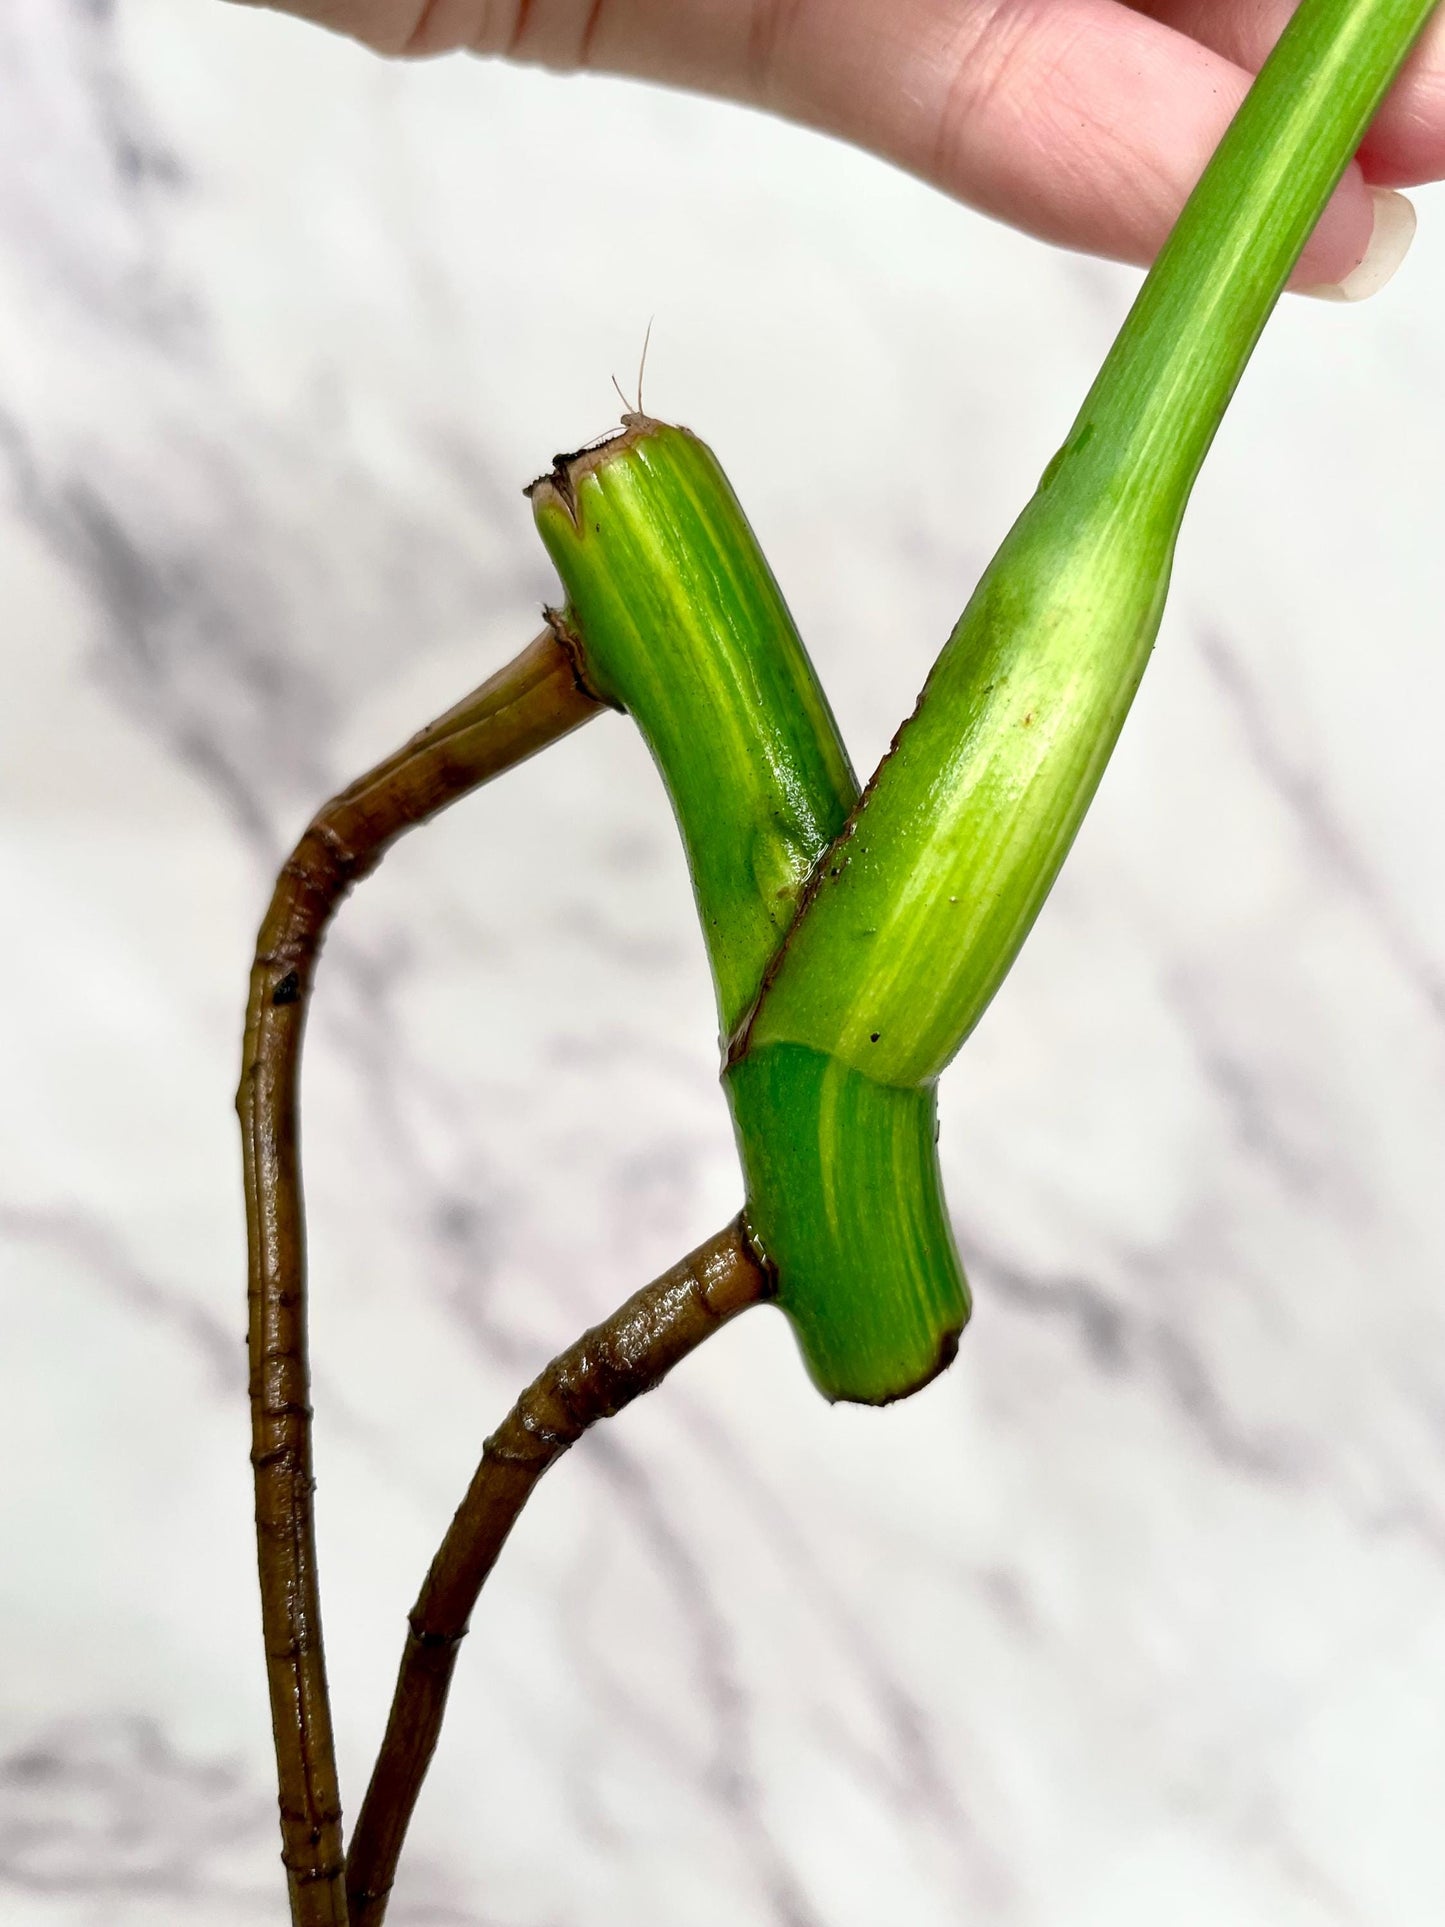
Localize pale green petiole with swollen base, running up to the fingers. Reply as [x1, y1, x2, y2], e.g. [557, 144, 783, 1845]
[751, 0, 1432, 1087]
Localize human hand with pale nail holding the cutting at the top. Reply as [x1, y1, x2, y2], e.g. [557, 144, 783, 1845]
[240, 0, 1445, 301]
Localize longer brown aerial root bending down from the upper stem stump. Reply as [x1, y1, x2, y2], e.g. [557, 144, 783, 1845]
[237, 632, 601, 1927]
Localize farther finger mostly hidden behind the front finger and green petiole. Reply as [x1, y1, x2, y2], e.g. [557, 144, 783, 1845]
[1139, 0, 1445, 187]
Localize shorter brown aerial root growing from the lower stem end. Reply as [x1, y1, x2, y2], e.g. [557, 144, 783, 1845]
[347, 1218, 775, 1927]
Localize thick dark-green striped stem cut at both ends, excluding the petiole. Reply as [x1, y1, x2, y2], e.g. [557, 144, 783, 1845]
[532, 416, 967, 1401]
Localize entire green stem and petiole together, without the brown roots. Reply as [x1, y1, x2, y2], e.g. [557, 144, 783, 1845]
[534, 0, 1433, 1403]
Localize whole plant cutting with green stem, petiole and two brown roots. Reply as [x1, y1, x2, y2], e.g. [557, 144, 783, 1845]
[241, 0, 1430, 1923]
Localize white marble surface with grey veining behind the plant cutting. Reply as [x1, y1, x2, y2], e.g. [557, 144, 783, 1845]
[0, 0, 1445, 1927]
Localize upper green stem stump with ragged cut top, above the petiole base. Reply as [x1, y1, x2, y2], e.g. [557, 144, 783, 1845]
[530, 414, 857, 1035]
